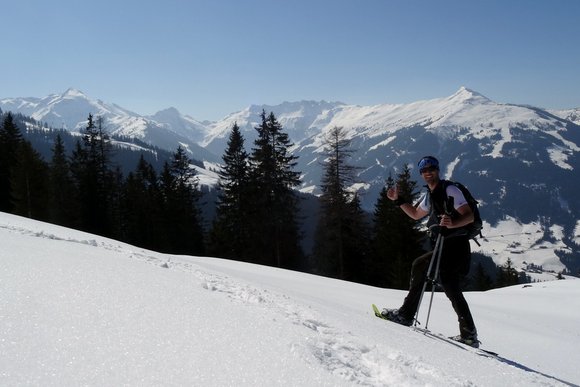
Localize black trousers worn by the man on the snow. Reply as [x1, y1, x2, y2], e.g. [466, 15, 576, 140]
[399, 236, 476, 337]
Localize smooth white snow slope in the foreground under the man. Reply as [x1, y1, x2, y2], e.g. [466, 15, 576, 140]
[0, 213, 580, 386]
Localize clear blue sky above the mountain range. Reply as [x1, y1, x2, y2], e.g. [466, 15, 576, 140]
[0, 0, 580, 120]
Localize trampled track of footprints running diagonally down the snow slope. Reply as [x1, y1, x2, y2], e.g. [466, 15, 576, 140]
[0, 221, 567, 386]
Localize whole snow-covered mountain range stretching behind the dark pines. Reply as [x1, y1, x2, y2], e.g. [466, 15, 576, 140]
[0, 87, 580, 274]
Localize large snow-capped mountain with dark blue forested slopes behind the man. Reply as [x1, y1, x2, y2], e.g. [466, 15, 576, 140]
[280, 88, 580, 273]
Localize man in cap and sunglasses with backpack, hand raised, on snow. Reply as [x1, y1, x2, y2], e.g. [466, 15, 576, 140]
[381, 156, 479, 348]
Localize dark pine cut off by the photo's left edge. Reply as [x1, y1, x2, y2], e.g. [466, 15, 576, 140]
[0, 112, 22, 212]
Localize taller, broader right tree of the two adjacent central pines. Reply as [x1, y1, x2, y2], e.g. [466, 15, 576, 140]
[248, 111, 302, 268]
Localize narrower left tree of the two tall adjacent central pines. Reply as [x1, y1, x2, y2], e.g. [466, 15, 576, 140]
[210, 123, 251, 260]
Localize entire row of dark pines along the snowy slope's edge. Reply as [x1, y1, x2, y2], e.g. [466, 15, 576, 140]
[0, 111, 517, 290]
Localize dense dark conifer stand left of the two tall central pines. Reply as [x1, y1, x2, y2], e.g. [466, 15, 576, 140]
[0, 113, 204, 254]
